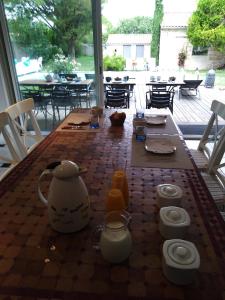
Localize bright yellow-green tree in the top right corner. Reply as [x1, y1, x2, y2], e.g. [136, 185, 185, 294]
[187, 0, 225, 51]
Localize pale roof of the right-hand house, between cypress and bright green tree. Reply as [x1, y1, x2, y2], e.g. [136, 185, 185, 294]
[161, 12, 191, 28]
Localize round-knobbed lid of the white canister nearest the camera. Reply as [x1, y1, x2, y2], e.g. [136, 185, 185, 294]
[163, 239, 200, 269]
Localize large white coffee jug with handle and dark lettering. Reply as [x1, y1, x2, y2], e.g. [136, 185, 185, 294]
[38, 160, 90, 233]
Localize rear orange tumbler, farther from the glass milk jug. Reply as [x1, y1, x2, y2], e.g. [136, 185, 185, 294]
[112, 170, 129, 208]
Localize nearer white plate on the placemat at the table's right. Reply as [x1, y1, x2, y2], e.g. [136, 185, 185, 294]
[145, 138, 176, 154]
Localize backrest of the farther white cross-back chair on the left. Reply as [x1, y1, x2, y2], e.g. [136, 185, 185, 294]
[5, 98, 43, 156]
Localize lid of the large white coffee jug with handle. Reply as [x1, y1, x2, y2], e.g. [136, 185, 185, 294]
[52, 160, 80, 178]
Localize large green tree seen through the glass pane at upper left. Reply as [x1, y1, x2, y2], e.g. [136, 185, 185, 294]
[5, 0, 92, 58]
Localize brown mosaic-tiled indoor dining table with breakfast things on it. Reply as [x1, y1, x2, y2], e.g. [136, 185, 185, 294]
[0, 109, 225, 300]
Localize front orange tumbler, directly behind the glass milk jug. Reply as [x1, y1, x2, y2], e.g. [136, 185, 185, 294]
[106, 188, 125, 211]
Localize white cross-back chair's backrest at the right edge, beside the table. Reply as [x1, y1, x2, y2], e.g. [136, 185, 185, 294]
[198, 100, 225, 182]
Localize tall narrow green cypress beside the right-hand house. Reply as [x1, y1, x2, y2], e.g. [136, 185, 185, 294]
[151, 0, 163, 65]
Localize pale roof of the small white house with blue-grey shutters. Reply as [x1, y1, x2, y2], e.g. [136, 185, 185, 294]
[107, 34, 152, 45]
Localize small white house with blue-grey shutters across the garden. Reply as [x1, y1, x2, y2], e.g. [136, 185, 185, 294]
[104, 34, 152, 70]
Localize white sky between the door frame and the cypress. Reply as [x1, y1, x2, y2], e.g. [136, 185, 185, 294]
[102, 0, 155, 26]
